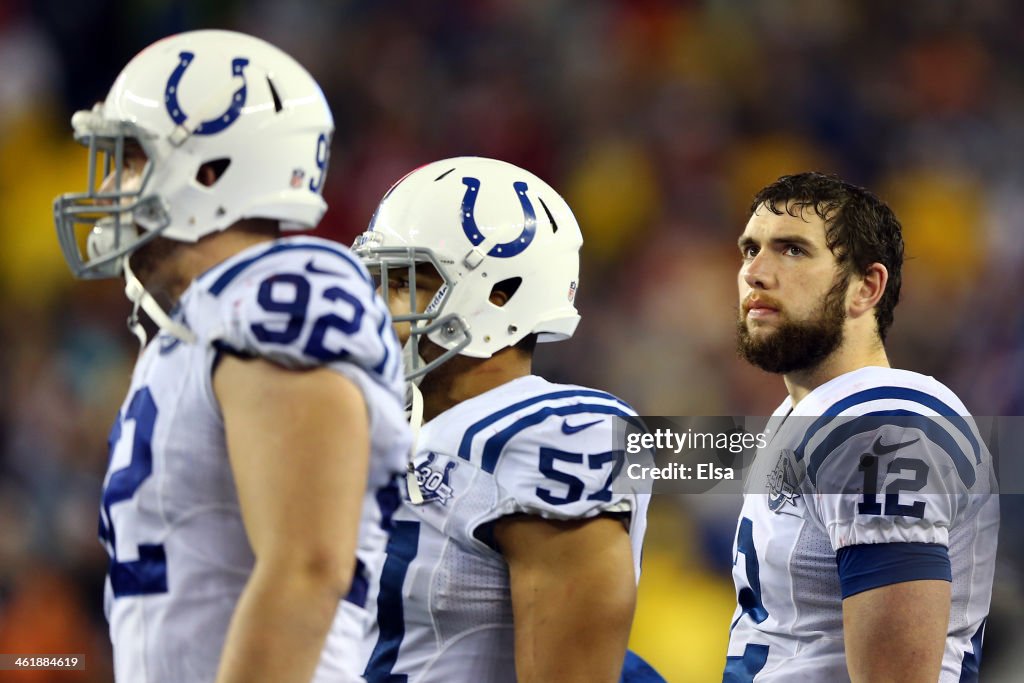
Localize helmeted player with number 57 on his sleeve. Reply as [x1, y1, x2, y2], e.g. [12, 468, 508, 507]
[355, 158, 648, 683]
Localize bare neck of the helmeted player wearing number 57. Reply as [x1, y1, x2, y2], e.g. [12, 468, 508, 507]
[420, 348, 532, 422]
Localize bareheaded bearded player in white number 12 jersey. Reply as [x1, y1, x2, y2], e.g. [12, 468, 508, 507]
[723, 173, 998, 683]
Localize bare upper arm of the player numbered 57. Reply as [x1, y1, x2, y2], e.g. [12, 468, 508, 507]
[495, 515, 636, 683]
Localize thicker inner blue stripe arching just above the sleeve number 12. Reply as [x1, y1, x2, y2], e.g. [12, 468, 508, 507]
[807, 411, 977, 494]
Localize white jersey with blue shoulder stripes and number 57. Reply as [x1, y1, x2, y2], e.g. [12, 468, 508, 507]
[365, 376, 649, 683]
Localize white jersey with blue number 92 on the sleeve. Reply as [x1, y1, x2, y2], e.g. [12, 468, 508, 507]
[99, 237, 412, 683]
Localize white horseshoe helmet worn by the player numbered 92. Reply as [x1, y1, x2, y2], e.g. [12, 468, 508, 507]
[54, 31, 334, 278]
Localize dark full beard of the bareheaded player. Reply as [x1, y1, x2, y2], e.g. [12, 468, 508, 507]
[736, 276, 850, 375]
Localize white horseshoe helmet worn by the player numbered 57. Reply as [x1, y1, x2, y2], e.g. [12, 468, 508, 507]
[353, 157, 583, 379]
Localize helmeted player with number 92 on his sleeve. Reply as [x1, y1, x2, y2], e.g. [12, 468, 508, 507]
[54, 31, 411, 683]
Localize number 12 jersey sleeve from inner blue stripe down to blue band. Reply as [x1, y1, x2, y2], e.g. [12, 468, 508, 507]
[804, 412, 983, 598]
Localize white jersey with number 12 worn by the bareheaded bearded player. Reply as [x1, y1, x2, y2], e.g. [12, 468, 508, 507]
[723, 368, 999, 683]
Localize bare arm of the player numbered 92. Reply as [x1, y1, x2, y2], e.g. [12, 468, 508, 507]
[214, 356, 370, 683]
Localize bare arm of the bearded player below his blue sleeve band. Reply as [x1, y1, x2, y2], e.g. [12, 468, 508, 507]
[843, 581, 951, 683]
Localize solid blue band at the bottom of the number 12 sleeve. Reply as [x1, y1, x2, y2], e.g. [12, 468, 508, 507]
[836, 543, 953, 600]
